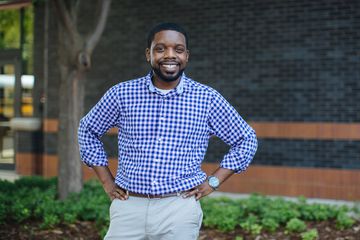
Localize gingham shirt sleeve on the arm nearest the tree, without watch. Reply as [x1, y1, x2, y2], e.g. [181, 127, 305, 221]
[78, 86, 120, 167]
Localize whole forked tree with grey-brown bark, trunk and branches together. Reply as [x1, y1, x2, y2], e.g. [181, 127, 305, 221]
[54, 0, 111, 199]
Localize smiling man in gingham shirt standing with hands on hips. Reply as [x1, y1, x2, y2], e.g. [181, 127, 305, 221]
[79, 23, 257, 240]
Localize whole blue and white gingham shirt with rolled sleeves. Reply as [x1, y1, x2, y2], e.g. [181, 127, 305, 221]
[78, 73, 257, 194]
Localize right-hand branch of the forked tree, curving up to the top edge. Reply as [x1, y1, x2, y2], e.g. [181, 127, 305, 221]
[86, 0, 111, 54]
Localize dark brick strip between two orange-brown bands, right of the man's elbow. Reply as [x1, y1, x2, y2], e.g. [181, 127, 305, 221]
[253, 139, 360, 169]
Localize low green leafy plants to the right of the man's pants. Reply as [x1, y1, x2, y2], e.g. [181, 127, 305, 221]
[202, 194, 355, 239]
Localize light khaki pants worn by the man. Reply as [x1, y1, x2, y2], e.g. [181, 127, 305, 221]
[104, 196, 203, 240]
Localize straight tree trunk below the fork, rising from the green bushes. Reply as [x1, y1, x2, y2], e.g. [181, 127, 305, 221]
[58, 67, 85, 199]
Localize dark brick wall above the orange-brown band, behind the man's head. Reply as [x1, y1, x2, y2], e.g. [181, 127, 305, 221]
[81, 0, 360, 122]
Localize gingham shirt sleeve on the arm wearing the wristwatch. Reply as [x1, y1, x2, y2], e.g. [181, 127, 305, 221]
[208, 92, 257, 173]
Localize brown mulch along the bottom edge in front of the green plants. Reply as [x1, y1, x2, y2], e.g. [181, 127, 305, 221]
[0, 221, 360, 240]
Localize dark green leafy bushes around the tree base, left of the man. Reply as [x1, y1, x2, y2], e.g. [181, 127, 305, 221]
[0, 177, 110, 234]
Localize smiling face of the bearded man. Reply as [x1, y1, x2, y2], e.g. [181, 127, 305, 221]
[146, 30, 189, 82]
